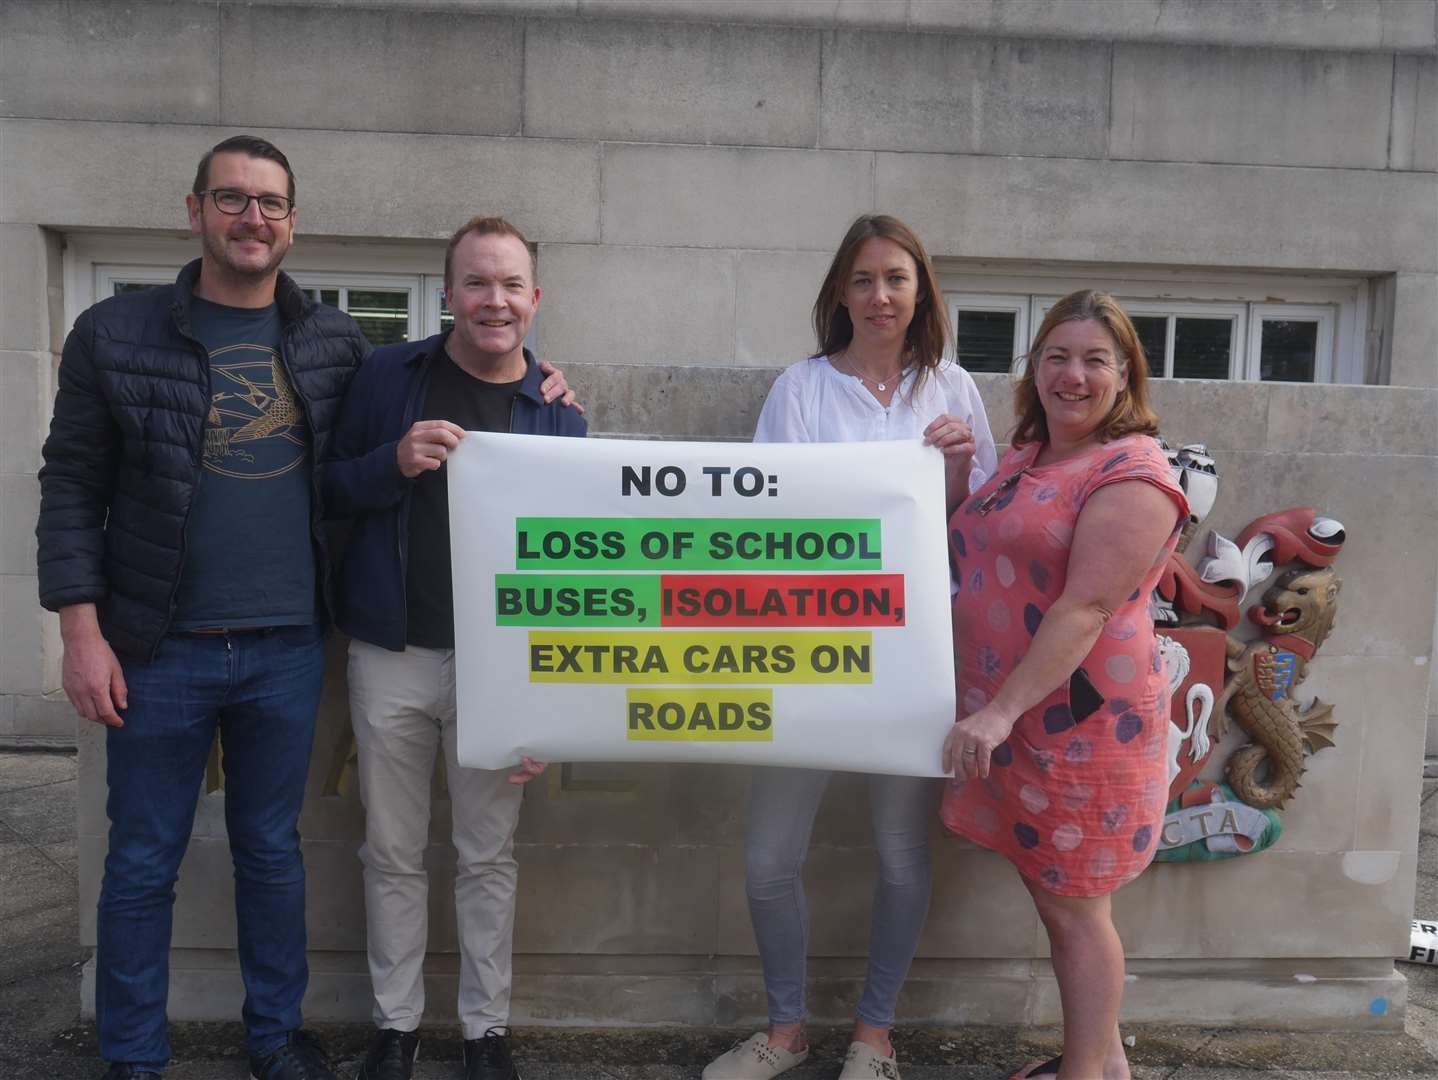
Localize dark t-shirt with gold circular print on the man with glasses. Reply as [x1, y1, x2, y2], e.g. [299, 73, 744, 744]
[171, 296, 315, 630]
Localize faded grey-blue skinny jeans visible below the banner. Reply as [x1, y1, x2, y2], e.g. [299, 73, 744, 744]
[745, 768, 939, 1027]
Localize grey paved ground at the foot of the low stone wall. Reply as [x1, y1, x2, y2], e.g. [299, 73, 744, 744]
[0, 754, 1438, 1080]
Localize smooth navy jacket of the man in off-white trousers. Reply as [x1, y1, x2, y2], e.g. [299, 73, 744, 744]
[325, 331, 588, 651]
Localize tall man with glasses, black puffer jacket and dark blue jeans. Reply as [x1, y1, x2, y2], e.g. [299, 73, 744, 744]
[36, 135, 368, 1080]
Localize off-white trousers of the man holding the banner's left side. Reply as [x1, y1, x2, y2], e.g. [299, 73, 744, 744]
[349, 641, 523, 1038]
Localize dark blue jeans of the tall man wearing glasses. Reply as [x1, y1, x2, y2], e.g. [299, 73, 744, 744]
[95, 626, 325, 1070]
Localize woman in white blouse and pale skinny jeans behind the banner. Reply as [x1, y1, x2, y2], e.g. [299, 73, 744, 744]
[703, 214, 997, 1080]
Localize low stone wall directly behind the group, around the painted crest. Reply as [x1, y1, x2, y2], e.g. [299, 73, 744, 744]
[64, 365, 1438, 1028]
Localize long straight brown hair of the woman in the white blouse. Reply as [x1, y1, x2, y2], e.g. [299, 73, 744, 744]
[814, 214, 953, 385]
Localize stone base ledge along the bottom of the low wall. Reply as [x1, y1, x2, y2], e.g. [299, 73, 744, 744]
[81, 949, 1429, 1041]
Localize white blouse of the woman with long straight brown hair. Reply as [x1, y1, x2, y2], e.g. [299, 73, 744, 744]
[754, 357, 998, 492]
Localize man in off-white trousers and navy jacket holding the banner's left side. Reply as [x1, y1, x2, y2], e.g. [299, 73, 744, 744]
[325, 217, 585, 1080]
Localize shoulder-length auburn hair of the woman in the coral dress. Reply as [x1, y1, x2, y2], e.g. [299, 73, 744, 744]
[1009, 289, 1159, 446]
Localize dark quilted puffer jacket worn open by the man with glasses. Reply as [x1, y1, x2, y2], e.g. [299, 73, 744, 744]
[35, 259, 370, 660]
